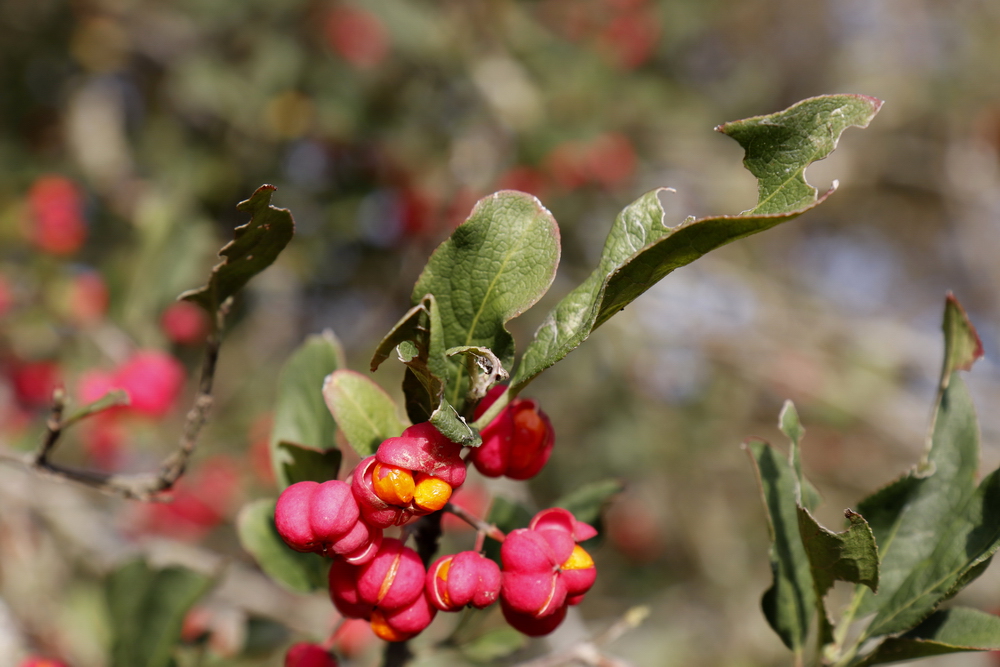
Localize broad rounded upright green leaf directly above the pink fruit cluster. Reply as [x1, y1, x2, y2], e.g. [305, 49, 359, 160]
[413, 190, 560, 407]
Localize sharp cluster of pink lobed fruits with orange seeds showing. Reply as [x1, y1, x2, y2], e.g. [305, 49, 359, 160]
[275, 387, 597, 642]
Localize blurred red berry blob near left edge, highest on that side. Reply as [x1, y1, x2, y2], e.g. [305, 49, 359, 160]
[28, 175, 87, 255]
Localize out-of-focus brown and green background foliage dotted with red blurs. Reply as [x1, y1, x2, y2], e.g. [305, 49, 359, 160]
[0, 0, 1000, 667]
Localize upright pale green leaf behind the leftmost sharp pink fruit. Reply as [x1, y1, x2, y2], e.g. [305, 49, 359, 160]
[270, 331, 344, 489]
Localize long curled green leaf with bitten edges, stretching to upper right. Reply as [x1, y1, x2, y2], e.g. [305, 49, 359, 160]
[512, 95, 882, 394]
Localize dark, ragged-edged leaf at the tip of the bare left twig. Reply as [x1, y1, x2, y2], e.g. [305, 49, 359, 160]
[178, 185, 295, 321]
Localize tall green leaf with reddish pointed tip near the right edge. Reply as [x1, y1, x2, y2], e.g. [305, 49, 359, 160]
[858, 298, 985, 635]
